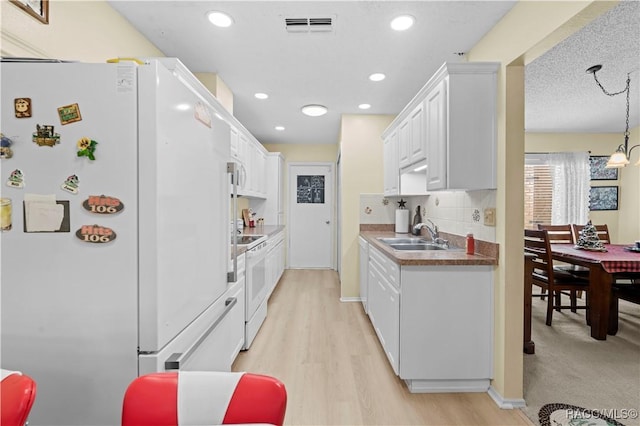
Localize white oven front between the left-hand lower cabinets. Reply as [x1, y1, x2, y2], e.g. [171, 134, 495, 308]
[244, 237, 269, 349]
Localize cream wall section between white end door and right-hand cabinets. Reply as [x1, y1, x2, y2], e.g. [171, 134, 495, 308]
[338, 114, 395, 299]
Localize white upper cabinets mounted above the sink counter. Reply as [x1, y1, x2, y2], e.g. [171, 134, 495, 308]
[382, 62, 499, 195]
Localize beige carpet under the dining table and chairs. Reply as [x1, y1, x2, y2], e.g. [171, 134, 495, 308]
[522, 298, 640, 426]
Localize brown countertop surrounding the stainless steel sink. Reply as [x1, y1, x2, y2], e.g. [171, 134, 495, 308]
[360, 230, 498, 265]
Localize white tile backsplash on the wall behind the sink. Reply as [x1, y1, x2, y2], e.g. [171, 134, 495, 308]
[360, 190, 496, 242]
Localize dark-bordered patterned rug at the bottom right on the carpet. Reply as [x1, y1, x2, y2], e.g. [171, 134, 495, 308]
[538, 404, 634, 426]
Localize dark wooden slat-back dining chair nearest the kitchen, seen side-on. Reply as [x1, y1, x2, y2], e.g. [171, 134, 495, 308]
[524, 229, 589, 326]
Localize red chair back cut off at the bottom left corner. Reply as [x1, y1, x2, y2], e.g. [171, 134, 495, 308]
[0, 370, 36, 426]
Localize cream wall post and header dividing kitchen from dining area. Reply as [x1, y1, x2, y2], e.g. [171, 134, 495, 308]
[467, 1, 616, 406]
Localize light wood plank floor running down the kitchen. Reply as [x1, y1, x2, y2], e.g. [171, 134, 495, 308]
[233, 270, 532, 426]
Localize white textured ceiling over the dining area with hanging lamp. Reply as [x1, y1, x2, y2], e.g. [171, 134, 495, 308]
[525, 1, 640, 133]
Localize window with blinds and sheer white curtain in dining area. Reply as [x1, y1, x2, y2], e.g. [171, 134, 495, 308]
[524, 152, 590, 229]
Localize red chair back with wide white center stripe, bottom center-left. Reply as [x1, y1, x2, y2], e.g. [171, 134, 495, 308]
[122, 371, 287, 426]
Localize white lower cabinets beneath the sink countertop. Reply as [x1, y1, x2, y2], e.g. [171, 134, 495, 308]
[368, 246, 493, 393]
